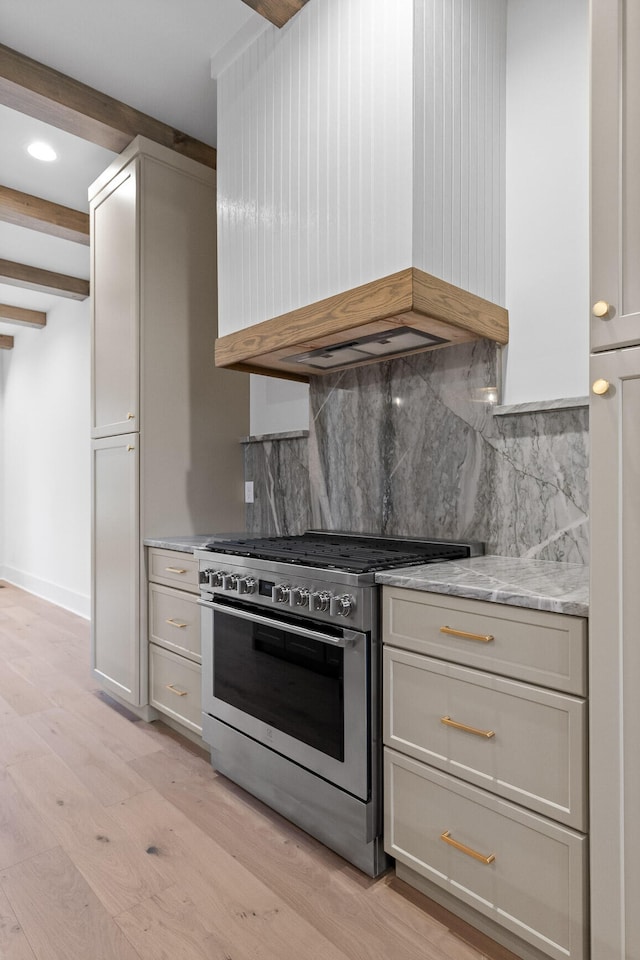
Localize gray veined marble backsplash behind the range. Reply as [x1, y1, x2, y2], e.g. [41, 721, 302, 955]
[245, 341, 589, 563]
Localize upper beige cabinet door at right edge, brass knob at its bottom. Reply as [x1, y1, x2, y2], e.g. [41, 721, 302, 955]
[591, 0, 640, 351]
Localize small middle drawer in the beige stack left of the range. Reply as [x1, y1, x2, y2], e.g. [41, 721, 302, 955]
[149, 583, 200, 663]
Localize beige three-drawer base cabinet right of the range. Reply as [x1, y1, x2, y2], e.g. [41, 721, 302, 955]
[383, 587, 588, 960]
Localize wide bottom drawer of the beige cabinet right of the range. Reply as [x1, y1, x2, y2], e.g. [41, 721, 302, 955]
[384, 748, 587, 960]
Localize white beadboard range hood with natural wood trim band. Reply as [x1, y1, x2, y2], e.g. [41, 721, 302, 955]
[216, 0, 507, 378]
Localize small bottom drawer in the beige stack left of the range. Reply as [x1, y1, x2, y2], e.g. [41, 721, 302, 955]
[149, 643, 202, 734]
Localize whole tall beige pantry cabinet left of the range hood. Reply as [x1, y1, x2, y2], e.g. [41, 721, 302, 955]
[89, 137, 248, 715]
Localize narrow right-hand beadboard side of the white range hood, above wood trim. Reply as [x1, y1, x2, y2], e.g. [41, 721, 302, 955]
[412, 0, 508, 304]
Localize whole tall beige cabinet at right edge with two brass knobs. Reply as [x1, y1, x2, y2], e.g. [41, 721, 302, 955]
[589, 0, 640, 960]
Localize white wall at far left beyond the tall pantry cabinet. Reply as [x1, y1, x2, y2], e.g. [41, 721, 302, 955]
[0, 300, 91, 616]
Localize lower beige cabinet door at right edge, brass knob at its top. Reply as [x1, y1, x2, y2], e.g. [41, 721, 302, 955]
[589, 347, 640, 960]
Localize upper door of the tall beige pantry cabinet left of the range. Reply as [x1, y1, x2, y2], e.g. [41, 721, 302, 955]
[91, 161, 140, 437]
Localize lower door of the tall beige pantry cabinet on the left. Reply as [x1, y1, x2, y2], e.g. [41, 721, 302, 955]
[91, 435, 141, 705]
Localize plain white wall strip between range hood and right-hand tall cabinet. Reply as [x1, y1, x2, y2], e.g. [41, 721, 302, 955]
[503, 0, 589, 403]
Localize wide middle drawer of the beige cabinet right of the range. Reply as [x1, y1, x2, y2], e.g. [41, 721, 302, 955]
[383, 646, 587, 830]
